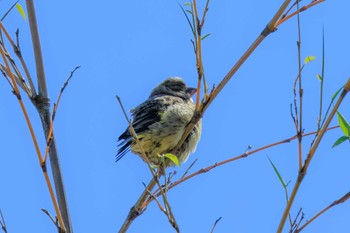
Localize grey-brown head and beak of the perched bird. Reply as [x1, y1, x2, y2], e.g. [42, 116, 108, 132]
[150, 77, 197, 100]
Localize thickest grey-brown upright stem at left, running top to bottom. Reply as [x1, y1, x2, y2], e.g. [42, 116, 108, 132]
[26, 0, 73, 233]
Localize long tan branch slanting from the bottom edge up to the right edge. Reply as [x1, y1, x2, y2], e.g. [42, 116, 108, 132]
[277, 78, 350, 233]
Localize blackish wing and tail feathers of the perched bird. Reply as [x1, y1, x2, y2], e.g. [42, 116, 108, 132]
[116, 96, 170, 161]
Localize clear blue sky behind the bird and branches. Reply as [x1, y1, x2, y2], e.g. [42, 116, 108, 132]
[0, 0, 350, 233]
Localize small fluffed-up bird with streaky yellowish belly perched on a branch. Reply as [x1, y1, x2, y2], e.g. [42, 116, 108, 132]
[116, 77, 202, 166]
